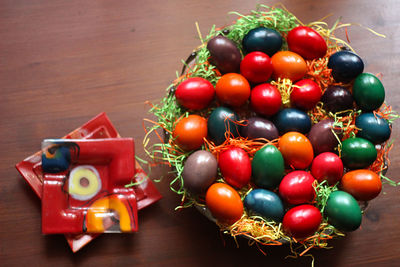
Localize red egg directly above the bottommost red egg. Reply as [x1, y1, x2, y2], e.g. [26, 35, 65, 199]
[279, 171, 315, 205]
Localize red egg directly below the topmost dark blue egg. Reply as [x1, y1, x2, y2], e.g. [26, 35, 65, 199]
[240, 52, 272, 83]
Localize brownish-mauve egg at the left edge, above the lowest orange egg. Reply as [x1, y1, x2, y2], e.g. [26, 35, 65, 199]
[182, 150, 218, 194]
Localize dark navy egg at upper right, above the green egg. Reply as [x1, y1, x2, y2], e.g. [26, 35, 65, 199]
[328, 51, 364, 83]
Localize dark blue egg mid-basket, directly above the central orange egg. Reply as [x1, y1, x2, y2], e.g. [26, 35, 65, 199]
[274, 108, 311, 135]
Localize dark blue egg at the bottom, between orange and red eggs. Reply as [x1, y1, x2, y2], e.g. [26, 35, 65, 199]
[244, 189, 284, 222]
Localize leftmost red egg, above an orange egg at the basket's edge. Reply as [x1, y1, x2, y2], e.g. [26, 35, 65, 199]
[175, 77, 215, 110]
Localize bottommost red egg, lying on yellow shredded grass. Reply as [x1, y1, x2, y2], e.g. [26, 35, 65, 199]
[283, 204, 322, 238]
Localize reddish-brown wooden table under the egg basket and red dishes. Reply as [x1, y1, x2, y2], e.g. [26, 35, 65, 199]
[0, 0, 400, 266]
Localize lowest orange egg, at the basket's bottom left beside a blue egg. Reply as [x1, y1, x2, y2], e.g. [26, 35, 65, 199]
[206, 183, 243, 224]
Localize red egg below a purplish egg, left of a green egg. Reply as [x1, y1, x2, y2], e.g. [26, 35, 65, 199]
[311, 152, 343, 185]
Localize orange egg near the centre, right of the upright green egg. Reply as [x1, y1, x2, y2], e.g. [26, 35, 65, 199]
[278, 132, 314, 169]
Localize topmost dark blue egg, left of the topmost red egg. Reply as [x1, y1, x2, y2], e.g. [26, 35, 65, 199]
[242, 27, 282, 57]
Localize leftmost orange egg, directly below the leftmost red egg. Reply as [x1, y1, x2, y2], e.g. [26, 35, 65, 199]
[172, 115, 207, 151]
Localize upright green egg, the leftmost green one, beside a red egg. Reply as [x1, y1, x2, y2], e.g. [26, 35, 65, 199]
[251, 145, 285, 189]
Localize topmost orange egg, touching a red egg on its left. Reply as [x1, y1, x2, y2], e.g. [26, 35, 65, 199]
[271, 51, 307, 82]
